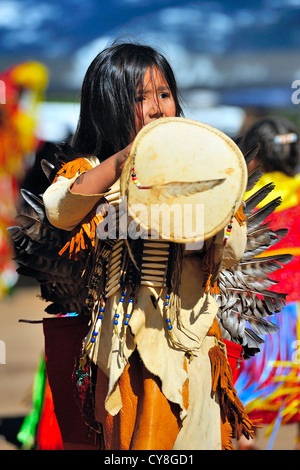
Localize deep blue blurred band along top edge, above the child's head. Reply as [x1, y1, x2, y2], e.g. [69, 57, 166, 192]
[0, 0, 300, 57]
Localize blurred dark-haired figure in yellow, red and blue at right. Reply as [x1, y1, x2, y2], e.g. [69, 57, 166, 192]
[236, 116, 300, 449]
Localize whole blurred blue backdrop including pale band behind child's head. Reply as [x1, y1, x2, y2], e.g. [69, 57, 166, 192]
[0, 0, 300, 100]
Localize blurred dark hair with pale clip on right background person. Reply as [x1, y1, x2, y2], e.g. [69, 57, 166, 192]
[243, 116, 300, 176]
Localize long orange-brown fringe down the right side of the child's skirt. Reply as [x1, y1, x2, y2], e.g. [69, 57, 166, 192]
[208, 319, 255, 450]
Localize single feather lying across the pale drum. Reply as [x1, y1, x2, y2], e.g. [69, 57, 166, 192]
[150, 178, 225, 198]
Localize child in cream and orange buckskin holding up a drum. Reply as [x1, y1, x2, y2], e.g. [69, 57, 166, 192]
[43, 43, 252, 450]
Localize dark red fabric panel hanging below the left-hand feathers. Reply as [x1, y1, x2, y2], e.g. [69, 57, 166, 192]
[43, 317, 98, 450]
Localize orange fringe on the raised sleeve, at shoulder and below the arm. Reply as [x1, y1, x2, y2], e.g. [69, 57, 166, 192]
[53, 158, 107, 260]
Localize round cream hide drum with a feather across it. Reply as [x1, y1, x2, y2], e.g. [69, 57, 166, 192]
[120, 118, 248, 243]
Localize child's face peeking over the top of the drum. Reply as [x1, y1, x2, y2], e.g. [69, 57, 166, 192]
[136, 68, 176, 132]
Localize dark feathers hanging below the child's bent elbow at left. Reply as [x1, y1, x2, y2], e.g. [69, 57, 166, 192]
[8, 164, 95, 314]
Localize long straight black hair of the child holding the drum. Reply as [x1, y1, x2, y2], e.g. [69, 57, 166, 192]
[71, 43, 182, 161]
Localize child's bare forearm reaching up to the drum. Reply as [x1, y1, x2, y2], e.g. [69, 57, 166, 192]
[70, 143, 132, 194]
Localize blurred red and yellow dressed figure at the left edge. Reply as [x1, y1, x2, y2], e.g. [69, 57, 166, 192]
[0, 62, 48, 299]
